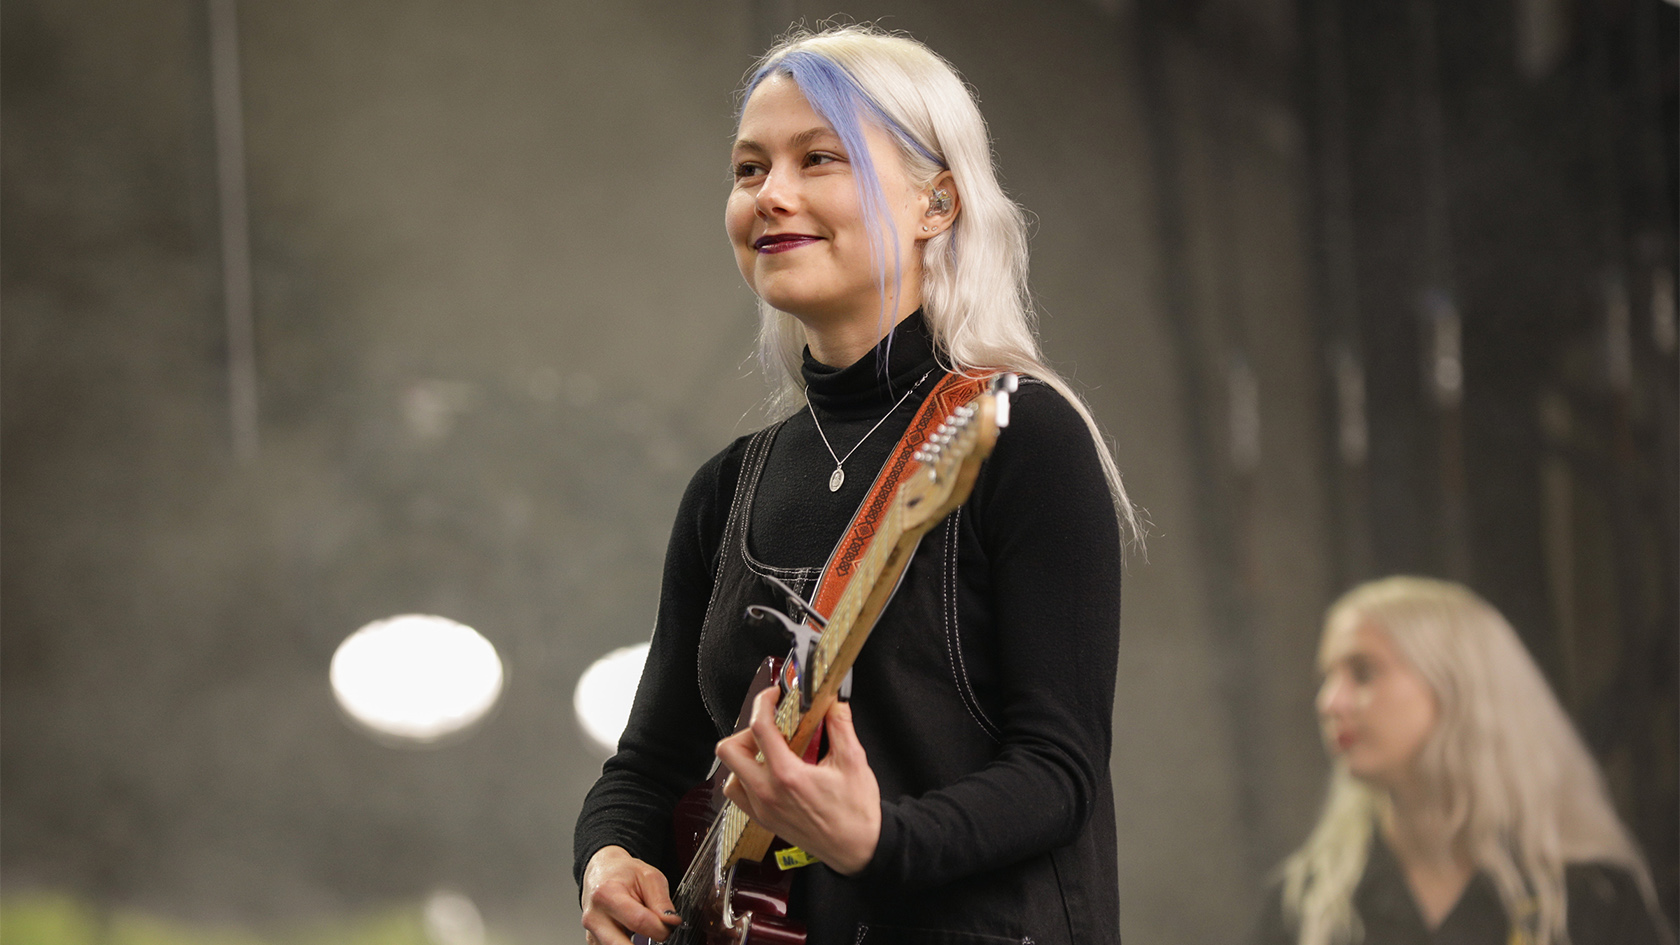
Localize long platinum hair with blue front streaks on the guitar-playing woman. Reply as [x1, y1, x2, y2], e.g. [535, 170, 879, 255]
[741, 25, 1142, 540]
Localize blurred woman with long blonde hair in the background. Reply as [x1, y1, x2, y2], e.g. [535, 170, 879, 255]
[1260, 577, 1673, 945]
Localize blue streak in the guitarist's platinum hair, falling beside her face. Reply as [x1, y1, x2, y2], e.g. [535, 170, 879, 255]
[736, 49, 944, 383]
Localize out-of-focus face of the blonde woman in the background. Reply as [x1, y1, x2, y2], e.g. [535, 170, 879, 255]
[1317, 620, 1440, 789]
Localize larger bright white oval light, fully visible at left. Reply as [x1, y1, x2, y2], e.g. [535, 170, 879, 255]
[329, 614, 502, 745]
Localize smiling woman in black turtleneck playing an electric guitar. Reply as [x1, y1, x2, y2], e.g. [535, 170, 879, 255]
[575, 27, 1136, 945]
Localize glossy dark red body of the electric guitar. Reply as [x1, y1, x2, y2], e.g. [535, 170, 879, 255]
[633, 656, 805, 945]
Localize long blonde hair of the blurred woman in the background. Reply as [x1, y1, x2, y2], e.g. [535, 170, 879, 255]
[1284, 577, 1656, 945]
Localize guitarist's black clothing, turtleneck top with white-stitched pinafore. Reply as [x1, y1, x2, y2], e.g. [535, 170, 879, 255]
[575, 314, 1121, 942]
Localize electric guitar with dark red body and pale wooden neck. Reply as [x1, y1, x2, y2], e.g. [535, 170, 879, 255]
[633, 373, 1016, 945]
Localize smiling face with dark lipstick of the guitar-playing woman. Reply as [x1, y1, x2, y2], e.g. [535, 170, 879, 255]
[724, 76, 927, 328]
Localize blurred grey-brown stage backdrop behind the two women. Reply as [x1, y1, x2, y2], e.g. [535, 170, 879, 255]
[0, 0, 1680, 945]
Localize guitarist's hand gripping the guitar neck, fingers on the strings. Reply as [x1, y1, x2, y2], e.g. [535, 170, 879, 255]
[717, 686, 880, 876]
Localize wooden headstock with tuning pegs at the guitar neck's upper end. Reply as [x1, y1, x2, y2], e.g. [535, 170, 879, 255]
[899, 373, 1020, 531]
